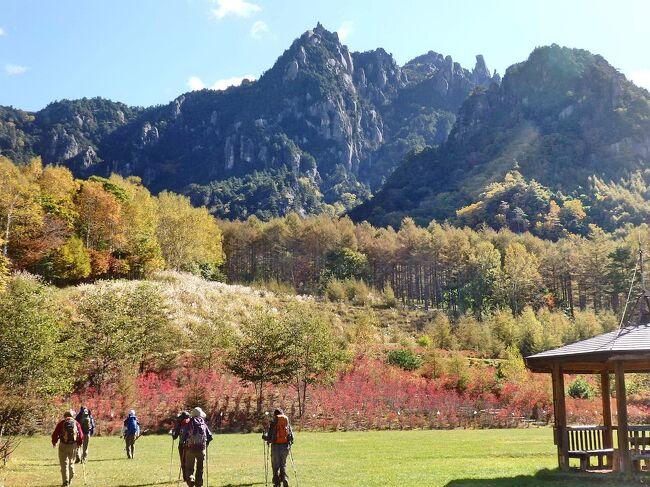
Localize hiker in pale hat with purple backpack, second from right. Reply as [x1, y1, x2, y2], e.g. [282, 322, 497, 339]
[181, 407, 212, 487]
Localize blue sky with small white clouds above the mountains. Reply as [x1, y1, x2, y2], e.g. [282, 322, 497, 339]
[0, 0, 650, 110]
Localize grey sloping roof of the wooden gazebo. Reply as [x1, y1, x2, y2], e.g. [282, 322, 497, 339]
[526, 323, 650, 373]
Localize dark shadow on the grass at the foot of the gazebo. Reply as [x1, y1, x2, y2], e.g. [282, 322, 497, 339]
[445, 469, 648, 487]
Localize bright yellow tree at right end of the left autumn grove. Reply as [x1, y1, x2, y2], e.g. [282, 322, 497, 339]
[156, 191, 223, 270]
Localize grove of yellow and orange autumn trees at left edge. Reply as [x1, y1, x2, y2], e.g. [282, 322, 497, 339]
[0, 157, 223, 284]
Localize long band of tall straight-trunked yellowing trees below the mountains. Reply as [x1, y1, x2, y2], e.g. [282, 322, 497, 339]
[219, 214, 648, 318]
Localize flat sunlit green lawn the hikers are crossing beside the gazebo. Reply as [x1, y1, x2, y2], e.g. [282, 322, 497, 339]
[0, 428, 643, 487]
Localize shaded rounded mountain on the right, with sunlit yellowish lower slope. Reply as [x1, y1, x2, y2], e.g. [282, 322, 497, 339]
[351, 45, 650, 233]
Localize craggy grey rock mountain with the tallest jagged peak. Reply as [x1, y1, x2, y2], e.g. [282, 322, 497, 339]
[0, 24, 500, 219]
